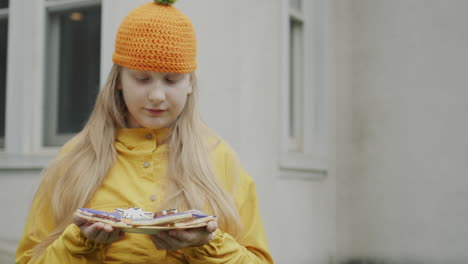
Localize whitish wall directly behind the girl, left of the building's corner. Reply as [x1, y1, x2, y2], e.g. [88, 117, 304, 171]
[0, 0, 336, 264]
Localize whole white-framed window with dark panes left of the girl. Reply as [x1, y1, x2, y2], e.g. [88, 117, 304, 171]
[0, 0, 102, 165]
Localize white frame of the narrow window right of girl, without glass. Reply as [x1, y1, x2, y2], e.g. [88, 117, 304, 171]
[279, 0, 330, 179]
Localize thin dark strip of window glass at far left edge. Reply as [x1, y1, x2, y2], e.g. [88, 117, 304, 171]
[0, 0, 8, 148]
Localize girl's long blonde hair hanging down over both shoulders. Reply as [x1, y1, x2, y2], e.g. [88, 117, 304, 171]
[33, 64, 241, 256]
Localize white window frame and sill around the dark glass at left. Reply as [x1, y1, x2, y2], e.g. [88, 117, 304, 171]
[0, 0, 102, 169]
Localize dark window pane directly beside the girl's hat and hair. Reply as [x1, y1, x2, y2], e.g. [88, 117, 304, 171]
[44, 6, 101, 146]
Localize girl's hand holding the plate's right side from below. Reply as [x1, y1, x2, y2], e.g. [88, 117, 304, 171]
[151, 221, 218, 250]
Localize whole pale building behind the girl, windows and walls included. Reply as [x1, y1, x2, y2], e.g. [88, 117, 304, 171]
[0, 0, 468, 264]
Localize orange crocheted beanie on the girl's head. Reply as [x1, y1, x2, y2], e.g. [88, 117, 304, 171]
[112, 0, 197, 73]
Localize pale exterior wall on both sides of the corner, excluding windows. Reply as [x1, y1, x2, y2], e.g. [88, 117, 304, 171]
[0, 0, 468, 264]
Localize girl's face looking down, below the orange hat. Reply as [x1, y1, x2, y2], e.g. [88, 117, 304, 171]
[118, 68, 192, 129]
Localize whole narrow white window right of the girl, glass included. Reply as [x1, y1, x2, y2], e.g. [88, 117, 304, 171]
[279, 0, 329, 177]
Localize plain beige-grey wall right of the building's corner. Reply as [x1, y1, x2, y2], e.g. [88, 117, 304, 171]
[335, 0, 468, 263]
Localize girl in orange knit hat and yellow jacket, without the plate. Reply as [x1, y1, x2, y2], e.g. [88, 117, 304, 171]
[16, 0, 273, 264]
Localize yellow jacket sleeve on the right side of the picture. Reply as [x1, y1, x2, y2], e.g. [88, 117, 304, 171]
[182, 141, 273, 264]
